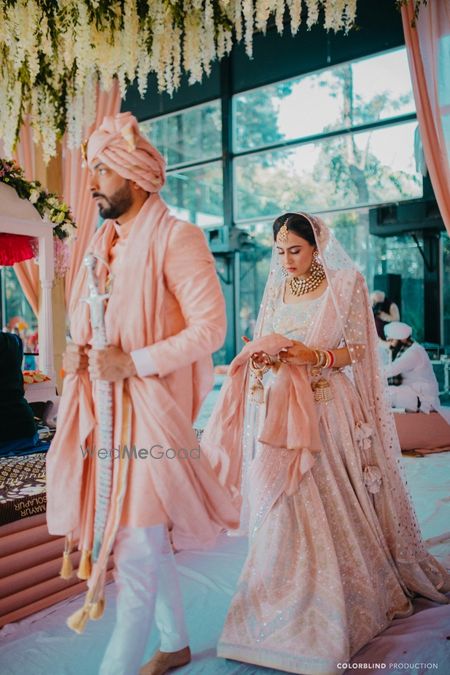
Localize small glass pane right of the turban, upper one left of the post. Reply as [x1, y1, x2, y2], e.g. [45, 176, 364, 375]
[140, 101, 222, 167]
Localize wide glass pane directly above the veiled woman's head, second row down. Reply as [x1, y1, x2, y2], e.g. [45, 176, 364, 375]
[234, 122, 423, 221]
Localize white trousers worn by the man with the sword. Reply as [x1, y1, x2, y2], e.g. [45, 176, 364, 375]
[100, 525, 189, 675]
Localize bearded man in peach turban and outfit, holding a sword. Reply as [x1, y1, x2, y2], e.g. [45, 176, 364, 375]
[47, 113, 238, 675]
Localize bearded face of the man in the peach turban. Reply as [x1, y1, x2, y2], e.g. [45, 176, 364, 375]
[89, 162, 133, 219]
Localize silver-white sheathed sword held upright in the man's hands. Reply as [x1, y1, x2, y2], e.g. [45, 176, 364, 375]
[83, 253, 113, 562]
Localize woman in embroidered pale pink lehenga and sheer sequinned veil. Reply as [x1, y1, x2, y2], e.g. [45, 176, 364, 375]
[202, 213, 450, 675]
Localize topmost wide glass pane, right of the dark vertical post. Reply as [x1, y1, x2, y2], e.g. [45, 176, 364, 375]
[233, 48, 415, 152]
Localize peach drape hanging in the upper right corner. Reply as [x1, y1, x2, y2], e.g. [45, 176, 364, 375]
[402, 0, 450, 233]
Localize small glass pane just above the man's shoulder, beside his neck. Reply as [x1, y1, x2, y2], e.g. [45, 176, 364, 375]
[161, 162, 223, 227]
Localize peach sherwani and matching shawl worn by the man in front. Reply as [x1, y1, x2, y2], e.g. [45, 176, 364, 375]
[47, 194, 238, 572]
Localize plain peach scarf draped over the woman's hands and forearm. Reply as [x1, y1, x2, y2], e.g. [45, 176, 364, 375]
[201, 335, 320, 540]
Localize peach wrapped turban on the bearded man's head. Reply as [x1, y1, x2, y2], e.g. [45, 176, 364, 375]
[87, 112, 166, 192]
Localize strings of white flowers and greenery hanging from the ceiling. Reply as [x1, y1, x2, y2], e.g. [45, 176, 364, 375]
[0, 0, 357, 161]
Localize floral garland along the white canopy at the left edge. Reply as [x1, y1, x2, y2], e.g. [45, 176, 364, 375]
[0, 158, 76, 241]
